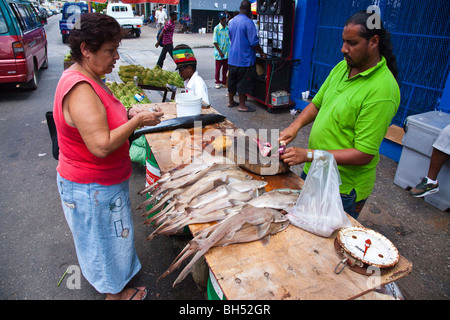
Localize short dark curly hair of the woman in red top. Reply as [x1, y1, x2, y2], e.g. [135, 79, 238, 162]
[69, 13, 126, 62]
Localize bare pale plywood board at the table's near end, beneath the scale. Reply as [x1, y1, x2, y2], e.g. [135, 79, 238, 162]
[205, 221, 412, 300]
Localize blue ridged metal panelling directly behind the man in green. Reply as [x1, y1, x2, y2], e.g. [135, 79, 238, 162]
[310, 0, 450, 125]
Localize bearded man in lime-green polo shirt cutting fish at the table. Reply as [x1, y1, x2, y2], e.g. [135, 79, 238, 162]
[279, 11, 400, 219]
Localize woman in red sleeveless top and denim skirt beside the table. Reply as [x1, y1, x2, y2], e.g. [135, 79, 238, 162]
[53, 13, 163, 299]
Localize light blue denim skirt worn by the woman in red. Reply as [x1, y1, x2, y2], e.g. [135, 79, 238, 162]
[57, 173, 141, 294]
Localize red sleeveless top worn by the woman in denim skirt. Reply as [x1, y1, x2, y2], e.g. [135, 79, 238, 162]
[53, 70, 131, 185]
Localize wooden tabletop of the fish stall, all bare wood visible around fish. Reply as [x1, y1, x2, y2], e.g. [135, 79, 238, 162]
[146, 104, 412, 300]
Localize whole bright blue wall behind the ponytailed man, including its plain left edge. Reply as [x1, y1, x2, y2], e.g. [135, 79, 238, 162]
[291, 0, 450, 126]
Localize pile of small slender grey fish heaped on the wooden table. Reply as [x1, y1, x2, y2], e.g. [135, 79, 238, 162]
[138, 155, 299, 286]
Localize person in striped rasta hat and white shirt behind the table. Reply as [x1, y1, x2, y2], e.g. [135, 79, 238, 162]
[173, 44, 210, 108]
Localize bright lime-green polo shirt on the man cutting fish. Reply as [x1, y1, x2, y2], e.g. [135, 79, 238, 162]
[303, 57, 400, 201]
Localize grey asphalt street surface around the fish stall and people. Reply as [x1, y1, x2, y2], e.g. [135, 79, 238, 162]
[0, 16, 450, 300]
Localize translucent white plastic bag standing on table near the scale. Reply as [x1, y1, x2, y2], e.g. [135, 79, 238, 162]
[286, 150, 352, 237]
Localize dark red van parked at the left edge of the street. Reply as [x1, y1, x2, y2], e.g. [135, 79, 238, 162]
[0, 0, 48, 89]
